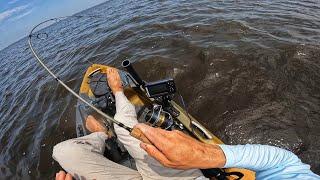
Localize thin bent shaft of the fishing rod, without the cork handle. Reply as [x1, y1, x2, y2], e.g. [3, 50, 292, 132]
[28, 16, 133, 132]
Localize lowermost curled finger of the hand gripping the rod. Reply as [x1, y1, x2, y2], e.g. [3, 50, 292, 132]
[140, 142, 172, 167]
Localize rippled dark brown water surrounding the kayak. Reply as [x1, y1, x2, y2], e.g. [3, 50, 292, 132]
[0, 0, 320, 179]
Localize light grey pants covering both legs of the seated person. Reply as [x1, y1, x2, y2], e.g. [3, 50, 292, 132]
[52, 92, 204, 179]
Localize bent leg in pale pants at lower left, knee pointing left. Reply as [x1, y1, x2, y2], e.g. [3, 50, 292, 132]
[52, 132, 142, 179]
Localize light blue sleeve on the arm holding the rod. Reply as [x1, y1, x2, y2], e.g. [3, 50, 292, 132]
[219, 144, 320, 179]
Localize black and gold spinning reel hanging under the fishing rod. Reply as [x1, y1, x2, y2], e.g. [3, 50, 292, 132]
[145, 104, 173, 130]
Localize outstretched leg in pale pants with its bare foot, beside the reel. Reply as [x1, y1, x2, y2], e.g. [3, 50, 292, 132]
[108, 70, 203, 179]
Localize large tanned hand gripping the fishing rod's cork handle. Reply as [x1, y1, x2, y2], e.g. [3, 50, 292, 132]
[135, 124, 226, 169]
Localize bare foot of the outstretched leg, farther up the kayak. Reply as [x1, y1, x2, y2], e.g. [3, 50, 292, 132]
[107, 67, 123, 94]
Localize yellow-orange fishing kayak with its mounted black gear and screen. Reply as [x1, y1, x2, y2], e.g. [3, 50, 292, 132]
[76, 62, 255, 180]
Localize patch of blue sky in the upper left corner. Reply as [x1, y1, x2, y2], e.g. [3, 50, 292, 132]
[0, 0, 105, 50]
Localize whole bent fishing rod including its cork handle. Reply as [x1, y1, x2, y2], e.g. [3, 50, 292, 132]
[28, 16, 151, 144]
